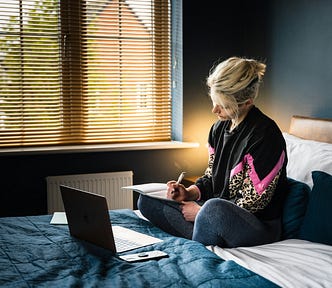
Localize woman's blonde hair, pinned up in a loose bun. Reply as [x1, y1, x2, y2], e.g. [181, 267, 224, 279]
[207, 57, 266, 115]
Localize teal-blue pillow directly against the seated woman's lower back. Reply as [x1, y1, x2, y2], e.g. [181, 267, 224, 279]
[282, 178, 310, 240]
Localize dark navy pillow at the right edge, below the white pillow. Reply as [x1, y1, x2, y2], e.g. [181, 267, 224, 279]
[300, 171, 332, 245]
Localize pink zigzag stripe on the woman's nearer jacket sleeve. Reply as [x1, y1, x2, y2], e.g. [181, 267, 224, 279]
[230, 151, 285, 195]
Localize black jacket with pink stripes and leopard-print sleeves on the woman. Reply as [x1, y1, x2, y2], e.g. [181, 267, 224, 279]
[196, 106, 287, 220]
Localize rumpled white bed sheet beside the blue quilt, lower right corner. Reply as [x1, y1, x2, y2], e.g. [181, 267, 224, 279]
[210, 239, 332, 288]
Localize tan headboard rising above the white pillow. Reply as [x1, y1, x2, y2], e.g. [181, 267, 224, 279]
[289, 115, 332, 143]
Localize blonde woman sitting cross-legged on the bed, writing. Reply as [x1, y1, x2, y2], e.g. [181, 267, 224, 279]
[138, 57, 287, 247]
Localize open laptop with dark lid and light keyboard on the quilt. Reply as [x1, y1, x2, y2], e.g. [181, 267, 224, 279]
[60, 185, 162, 254]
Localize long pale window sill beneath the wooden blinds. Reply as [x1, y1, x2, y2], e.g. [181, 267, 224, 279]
[0, 141, 199, 156]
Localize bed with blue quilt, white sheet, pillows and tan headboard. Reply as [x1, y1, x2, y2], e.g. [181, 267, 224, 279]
[0, 117, 332, 288]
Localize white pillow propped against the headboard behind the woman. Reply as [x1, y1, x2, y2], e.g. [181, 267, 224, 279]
[283, 132, 332, 188]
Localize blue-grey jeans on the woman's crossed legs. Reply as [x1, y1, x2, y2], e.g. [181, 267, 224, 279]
[137, 195, 281, 247]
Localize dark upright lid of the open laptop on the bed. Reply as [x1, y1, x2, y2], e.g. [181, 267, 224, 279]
[60, 185, 116, 254]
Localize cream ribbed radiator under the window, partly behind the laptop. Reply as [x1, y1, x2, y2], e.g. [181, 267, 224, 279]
[46, 171, 133, 214]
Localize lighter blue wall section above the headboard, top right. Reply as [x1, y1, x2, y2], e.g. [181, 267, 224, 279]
[263, 0, 332, 130]
